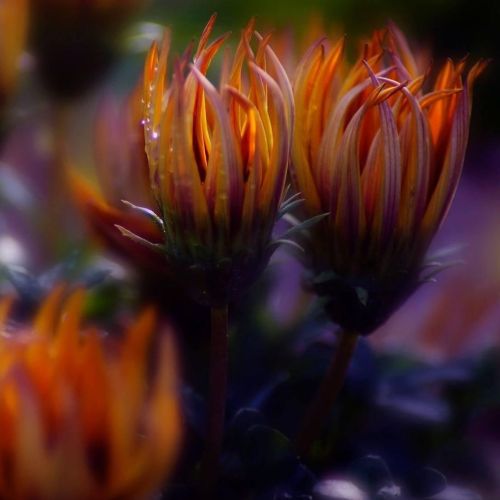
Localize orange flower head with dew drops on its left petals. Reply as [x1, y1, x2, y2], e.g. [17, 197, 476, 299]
[122, 18, 293, 304]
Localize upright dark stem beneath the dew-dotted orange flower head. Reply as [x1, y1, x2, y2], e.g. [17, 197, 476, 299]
[201, 305, 228, 497]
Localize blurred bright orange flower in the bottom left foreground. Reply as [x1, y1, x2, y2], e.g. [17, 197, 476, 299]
[0, 288, 180, 500]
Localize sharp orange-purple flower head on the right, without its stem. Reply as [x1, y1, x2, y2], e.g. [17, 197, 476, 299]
[292, 26, 485, 333]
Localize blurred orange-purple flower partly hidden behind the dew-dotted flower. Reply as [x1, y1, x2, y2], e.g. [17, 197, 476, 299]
[69, 86, 169, 275]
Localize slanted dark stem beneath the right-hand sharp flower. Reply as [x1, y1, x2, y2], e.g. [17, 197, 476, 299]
[297, 330, 359, 456]
